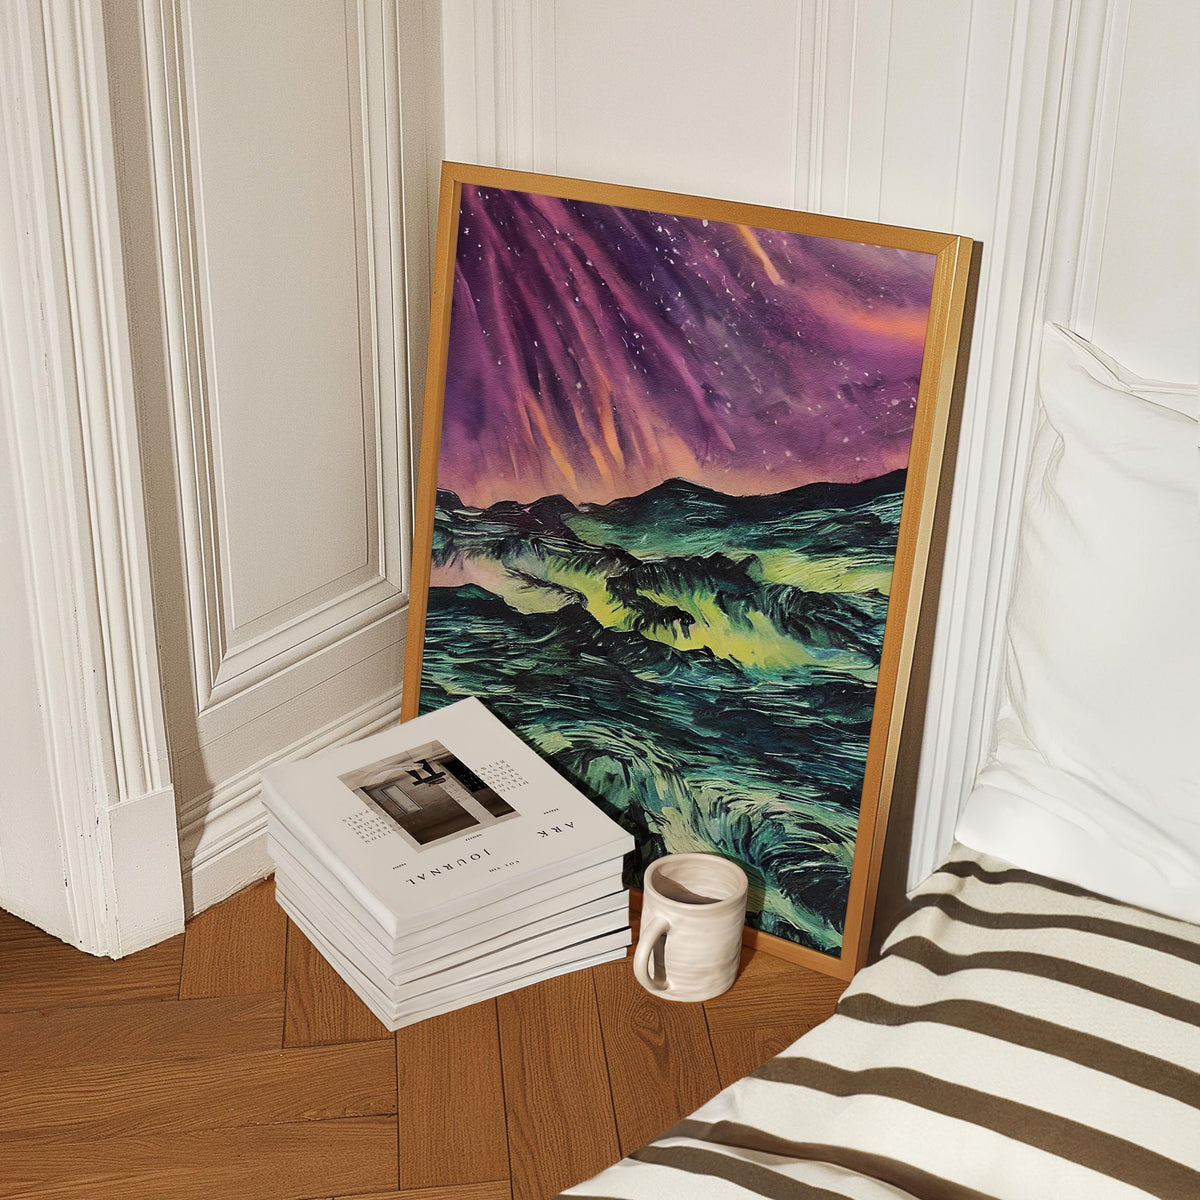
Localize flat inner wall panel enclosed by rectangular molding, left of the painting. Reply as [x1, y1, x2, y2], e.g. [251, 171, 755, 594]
[186, 0, 378, 644]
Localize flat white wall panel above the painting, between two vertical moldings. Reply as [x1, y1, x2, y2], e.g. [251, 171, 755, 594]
[554, 0, 799, 204]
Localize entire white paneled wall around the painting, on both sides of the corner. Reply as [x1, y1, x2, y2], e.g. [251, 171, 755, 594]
[0, 0, 1200, 953]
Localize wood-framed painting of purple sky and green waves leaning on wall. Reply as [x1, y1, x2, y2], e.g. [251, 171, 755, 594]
[403, 163, 972, 978]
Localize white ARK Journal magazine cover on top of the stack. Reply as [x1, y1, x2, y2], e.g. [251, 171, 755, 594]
[263, 698, 632, 936]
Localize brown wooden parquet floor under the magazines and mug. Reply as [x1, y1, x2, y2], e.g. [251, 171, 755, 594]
[0, 881, 842, 1200]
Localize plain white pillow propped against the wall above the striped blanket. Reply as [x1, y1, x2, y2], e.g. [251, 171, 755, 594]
[956, 326, 1200, 922]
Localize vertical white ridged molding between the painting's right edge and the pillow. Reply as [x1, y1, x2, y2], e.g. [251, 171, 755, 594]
[908, 0, 1124, 884]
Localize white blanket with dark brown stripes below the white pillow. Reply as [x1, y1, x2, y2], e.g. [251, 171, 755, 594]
[563, 847, 1200, 1200]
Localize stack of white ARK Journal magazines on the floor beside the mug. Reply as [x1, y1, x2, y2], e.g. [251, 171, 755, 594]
[263, 698, 634, 1030]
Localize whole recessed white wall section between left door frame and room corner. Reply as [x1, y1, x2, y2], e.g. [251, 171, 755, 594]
[126, 0, 442, 913]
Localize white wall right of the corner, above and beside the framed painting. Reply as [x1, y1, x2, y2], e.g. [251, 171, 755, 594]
[443, 0, 1200, 902]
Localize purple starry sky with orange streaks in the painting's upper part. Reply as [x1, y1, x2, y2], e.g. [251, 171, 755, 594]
[438, 186, 934, 506]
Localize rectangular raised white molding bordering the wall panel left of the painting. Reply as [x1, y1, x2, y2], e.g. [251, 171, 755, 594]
[144, 0, 410, 714]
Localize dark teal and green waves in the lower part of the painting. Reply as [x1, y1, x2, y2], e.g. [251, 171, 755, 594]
[421, 472, 904, 952]
